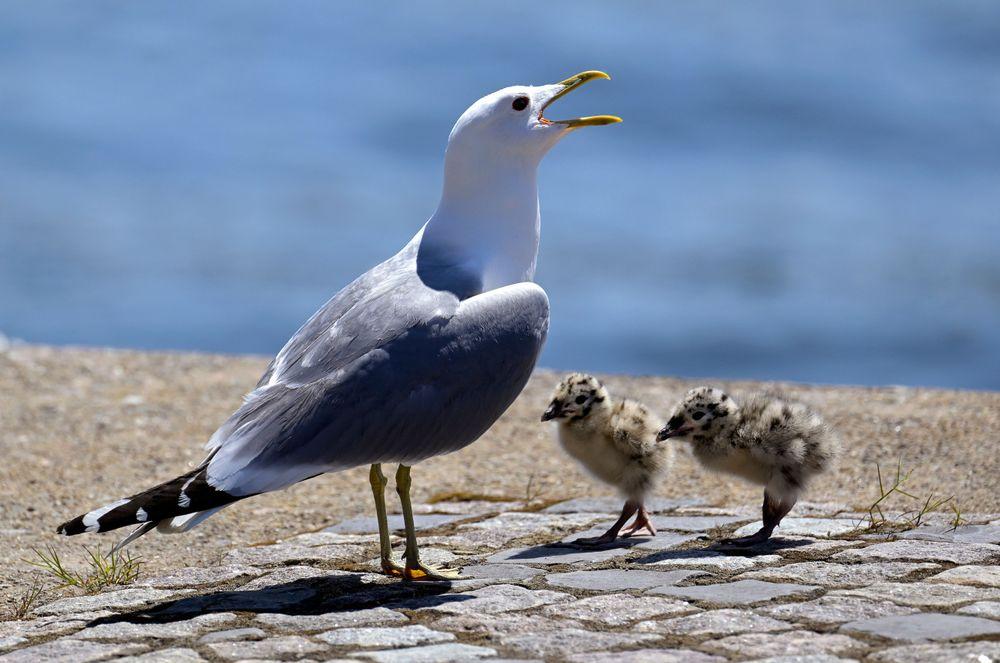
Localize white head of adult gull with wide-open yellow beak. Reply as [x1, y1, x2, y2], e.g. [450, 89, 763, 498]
[448, 71, 621, 163]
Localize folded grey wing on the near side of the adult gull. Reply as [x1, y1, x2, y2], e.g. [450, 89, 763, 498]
[208, 280, 548, 495]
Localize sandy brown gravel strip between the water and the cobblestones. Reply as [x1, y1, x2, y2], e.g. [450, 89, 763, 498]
[0, 346, 1000, 613]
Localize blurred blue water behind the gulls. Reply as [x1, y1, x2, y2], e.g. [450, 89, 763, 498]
[0, 0, 1000, 388]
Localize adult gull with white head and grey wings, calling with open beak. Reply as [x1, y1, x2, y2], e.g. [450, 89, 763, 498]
[58, 71, 621, 580]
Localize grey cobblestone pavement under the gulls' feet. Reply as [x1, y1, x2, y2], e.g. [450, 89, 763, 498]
[0, 499, 1000, 663]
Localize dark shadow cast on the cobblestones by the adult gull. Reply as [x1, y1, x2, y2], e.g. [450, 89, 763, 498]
[88, 573, 458, 626]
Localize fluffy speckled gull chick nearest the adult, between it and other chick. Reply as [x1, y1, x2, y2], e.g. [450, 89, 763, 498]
[542, 373, 671, 545]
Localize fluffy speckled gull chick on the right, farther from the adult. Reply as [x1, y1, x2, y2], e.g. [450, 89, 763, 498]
[656, 387, 840, 546]
